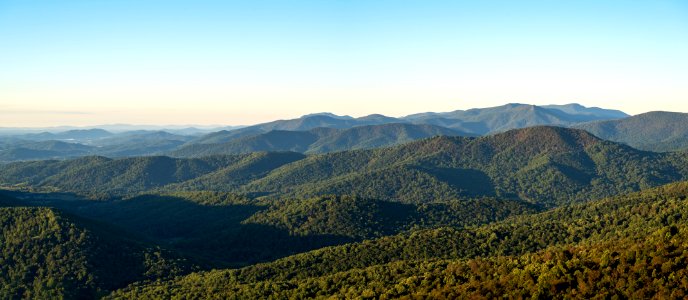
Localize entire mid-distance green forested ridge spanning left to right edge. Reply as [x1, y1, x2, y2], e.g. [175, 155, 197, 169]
[0, 127, 688, 206]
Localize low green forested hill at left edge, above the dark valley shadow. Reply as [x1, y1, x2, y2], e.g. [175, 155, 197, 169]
[0, 156, 253, 197]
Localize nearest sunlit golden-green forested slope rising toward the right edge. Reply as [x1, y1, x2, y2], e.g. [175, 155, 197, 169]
[111, 182, 688, 299]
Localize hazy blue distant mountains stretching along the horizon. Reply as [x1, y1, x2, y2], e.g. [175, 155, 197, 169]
[0, 104, 668, 162]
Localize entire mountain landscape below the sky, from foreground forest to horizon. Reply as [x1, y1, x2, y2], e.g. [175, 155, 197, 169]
[0, 104, 688, 299]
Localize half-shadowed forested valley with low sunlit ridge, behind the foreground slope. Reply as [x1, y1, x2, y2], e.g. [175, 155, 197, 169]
[12, 192, 538, 267]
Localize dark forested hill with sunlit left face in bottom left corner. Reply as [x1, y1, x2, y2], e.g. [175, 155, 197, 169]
[0, 195, 192, 299]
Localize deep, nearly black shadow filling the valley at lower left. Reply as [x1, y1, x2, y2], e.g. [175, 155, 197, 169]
[5, 192, 354, 268]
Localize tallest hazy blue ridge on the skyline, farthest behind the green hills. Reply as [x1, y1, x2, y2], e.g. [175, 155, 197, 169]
[191, 103, 628, 145]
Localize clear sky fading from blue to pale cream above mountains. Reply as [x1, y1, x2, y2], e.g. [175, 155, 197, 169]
[0, 0, 688, 127]
